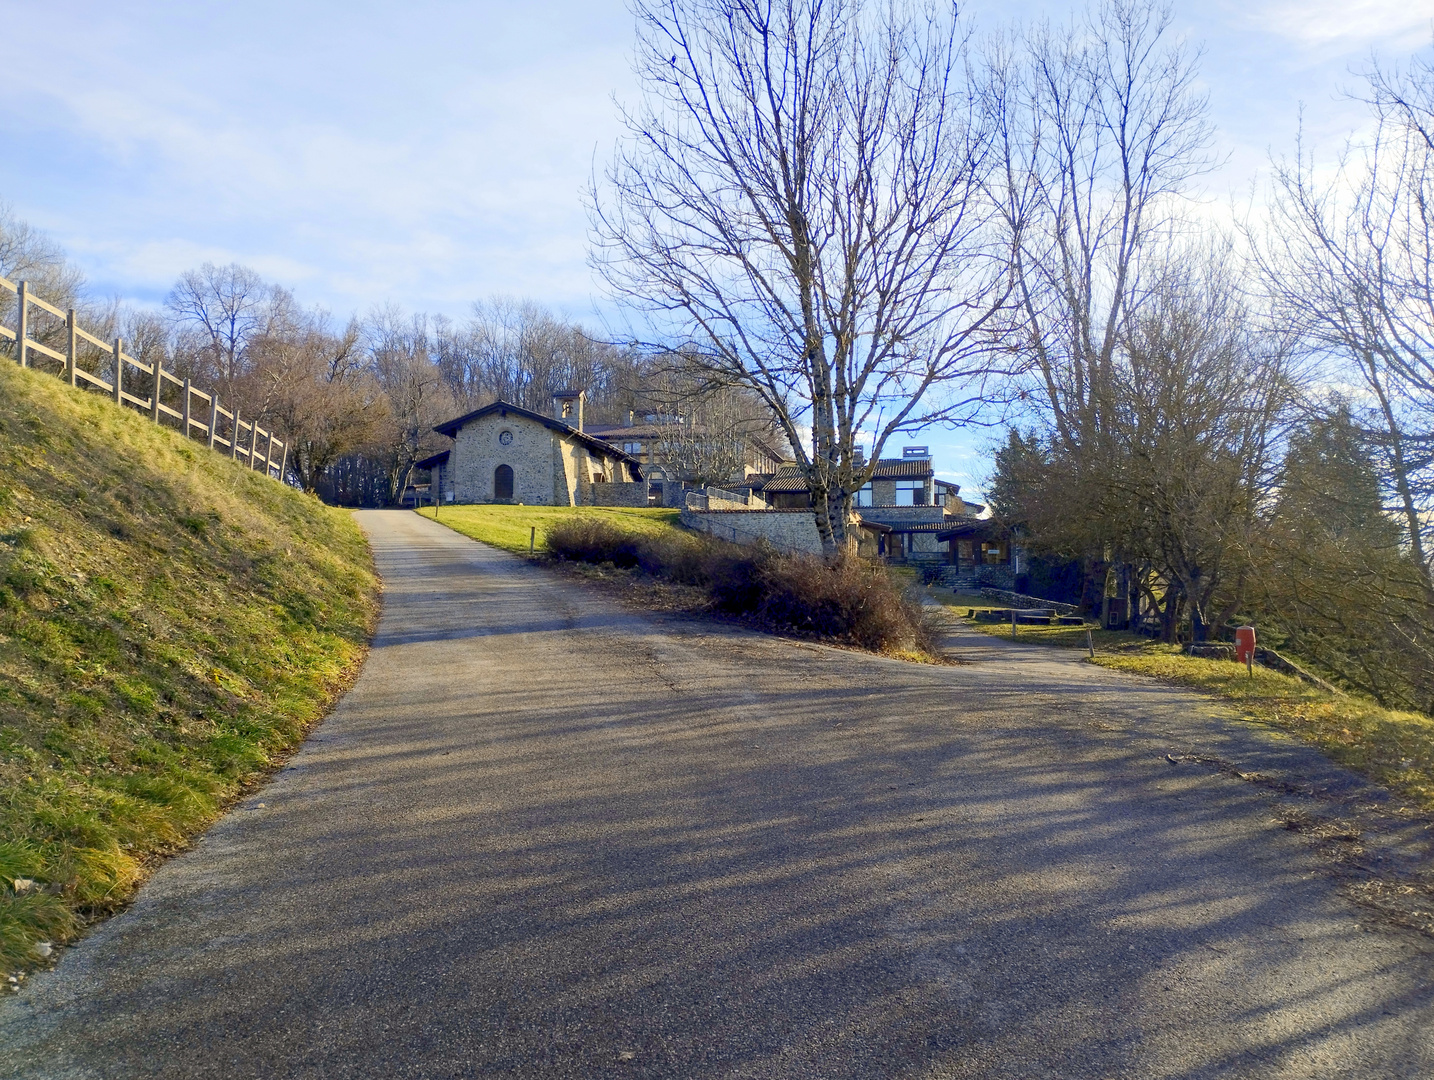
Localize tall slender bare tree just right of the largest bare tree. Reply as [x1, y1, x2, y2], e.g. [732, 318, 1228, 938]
[988, 0, 1212, 462]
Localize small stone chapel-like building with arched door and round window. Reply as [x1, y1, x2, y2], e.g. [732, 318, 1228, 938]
[419, 392, 647, 506]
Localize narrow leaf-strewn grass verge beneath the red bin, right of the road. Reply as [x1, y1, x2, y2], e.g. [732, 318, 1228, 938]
[932, 589, 1434, 810]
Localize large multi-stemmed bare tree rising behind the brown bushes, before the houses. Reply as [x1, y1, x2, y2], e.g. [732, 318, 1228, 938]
[591, 0, 1008, 552]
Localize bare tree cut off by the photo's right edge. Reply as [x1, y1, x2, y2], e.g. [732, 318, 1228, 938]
[1256, 52, 1434, 608]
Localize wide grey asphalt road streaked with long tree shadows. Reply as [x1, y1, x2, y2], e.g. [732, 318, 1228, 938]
[0, 512, 1434, 1080]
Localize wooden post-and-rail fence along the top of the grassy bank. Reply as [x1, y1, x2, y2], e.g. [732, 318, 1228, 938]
[0, 277, 288, 480]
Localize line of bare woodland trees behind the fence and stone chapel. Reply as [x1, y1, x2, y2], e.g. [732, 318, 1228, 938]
[0, 207, 770, 506]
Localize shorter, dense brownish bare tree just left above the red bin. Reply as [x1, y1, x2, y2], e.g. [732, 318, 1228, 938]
[1106, 255, 1296, 640]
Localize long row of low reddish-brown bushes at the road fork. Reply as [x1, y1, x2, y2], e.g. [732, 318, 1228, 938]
[545, 518, 934, 654]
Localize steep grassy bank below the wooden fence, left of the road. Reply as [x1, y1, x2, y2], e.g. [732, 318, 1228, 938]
[0, 363, 377, 968]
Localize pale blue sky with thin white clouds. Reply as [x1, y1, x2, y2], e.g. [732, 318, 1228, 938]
[0, 0, 1434, 489]
